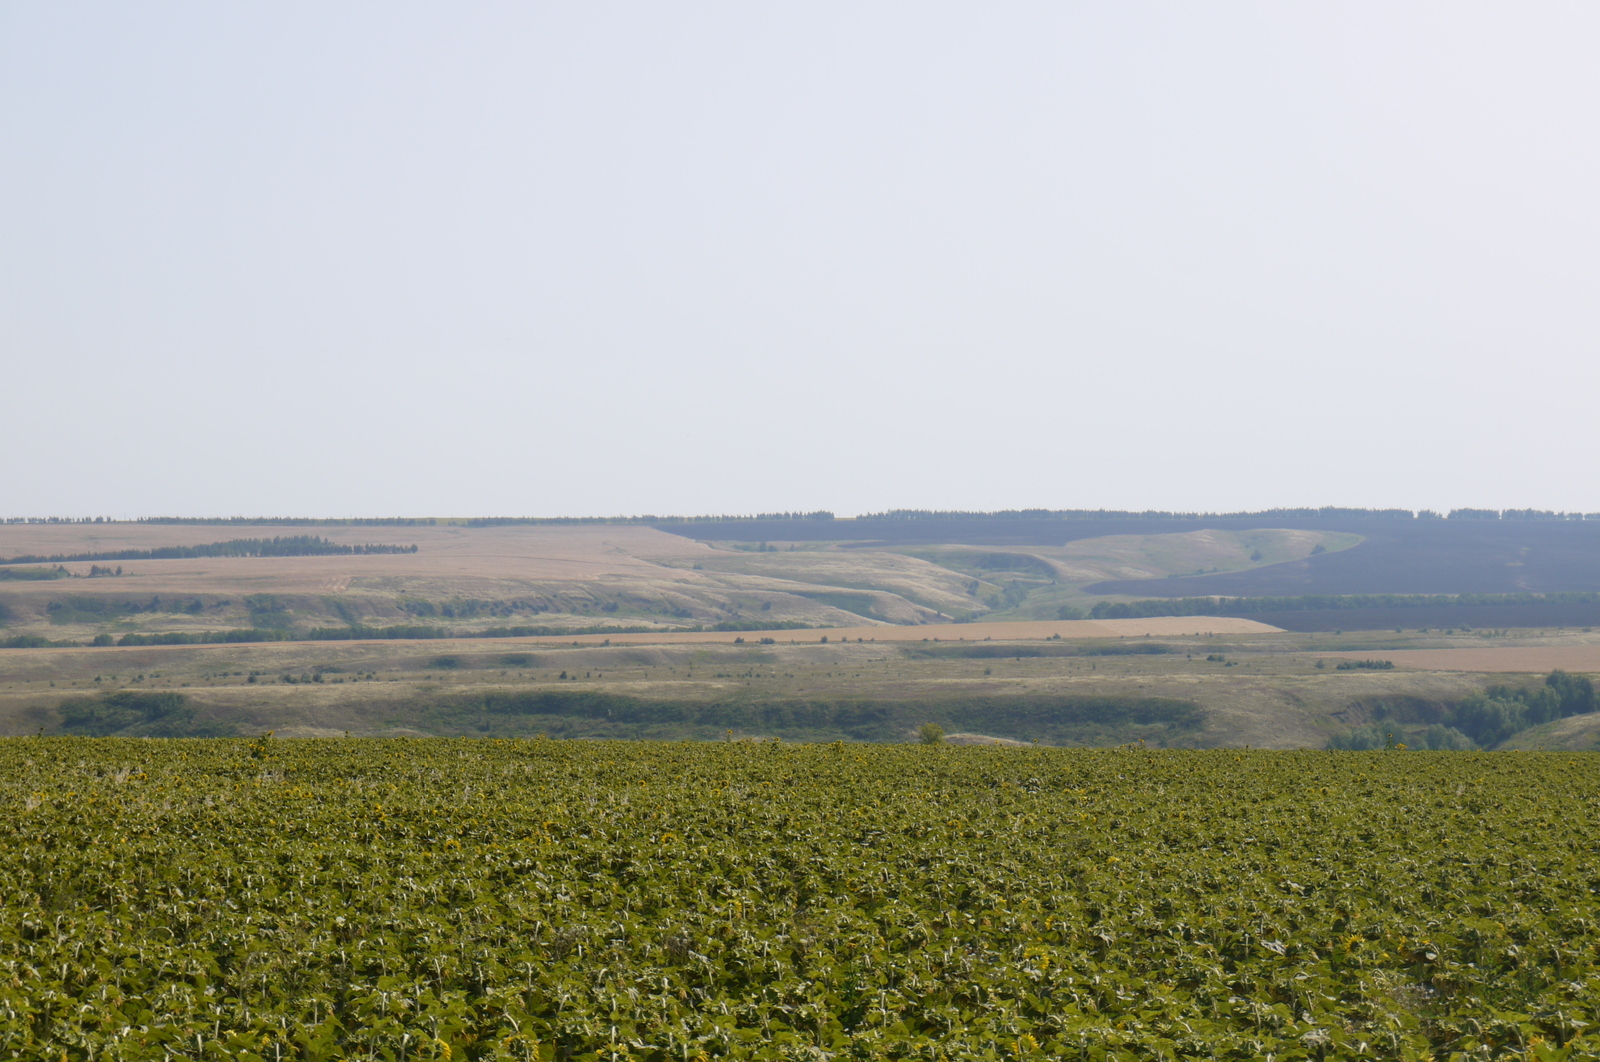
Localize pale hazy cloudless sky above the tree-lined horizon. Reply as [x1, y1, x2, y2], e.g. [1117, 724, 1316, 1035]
[0, 0, 1600, 515]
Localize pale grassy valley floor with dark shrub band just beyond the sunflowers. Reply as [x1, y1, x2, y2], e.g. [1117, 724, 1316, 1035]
[0, 619, 1600, 749]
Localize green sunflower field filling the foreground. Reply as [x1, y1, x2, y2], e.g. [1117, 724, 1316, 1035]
[0, 737, 1600, 1062]
